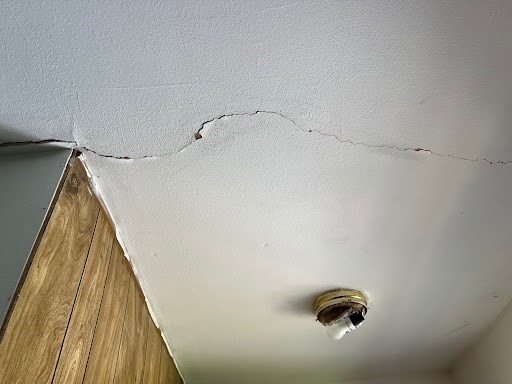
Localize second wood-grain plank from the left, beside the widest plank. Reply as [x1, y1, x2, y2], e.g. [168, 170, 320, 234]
[53, 211, 114, 383]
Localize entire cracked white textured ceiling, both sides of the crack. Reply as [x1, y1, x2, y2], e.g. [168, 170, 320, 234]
[0, 1, 512, 384]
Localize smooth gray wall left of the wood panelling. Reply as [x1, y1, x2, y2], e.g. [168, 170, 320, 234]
[0, 144, 71, 325]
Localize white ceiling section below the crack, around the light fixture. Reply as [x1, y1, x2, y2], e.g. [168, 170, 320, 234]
[82, 114, 512, 382]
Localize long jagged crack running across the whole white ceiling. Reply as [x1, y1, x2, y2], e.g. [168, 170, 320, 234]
[0, 110, 512, 165]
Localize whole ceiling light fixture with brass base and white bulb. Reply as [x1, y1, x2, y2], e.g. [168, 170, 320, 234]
[313, 288, 368, 340]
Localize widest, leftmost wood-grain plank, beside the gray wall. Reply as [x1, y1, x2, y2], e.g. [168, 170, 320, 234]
[0, 161, 99, 383]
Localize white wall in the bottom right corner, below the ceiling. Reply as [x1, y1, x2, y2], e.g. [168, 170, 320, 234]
[453, 302, 512, 384]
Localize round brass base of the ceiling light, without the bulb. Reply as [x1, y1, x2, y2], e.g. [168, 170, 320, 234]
[313, 288, 368, 326]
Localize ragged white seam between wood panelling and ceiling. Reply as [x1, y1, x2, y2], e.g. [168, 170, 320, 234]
[78, 155, 186, 384]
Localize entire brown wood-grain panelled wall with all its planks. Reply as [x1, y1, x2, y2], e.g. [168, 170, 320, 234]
[0, 160, 181, 384]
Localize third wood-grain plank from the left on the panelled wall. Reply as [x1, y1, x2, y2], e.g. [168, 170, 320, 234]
[84, 244, 130, 383]
